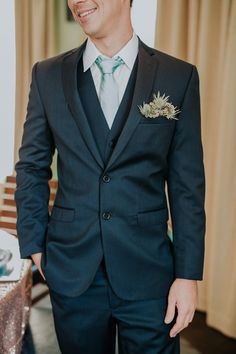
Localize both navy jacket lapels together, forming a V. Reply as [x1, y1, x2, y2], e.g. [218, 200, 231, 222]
[62, 40, 159, 169]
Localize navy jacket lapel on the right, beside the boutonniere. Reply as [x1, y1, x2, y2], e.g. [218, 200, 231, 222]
[106, 40, 159, 168]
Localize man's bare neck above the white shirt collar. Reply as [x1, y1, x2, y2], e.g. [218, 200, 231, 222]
[90, 27, 133, 57]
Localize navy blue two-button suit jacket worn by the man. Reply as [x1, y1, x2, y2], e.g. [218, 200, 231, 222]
[15, 40, 205, 300]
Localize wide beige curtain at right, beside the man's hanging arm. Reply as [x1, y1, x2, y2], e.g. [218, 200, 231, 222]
[156, 0, 236, 337]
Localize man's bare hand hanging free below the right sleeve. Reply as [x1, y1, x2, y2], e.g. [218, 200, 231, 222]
[165, 278, 198, 337]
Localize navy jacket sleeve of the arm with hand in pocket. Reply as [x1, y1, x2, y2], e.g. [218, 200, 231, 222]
[15, 63, 55, 258]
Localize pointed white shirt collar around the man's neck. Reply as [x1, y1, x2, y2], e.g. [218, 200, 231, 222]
[83, 32, 139, 72]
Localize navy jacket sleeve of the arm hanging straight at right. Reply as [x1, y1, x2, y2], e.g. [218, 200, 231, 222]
[167, 66, 205, 280]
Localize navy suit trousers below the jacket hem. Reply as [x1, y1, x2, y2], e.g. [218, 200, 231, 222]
[49, 261, 180, 354]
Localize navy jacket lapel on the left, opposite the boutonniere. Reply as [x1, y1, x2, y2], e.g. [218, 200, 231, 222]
[62, 41, 104, 169]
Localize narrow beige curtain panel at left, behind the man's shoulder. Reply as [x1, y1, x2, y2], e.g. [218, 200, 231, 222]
[15, 0, 56, 161]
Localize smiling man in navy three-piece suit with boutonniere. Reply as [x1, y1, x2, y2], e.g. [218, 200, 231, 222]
[16, 0, 205, 354]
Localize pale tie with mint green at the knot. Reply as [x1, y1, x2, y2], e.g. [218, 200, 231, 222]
[95, 56, 124, 129]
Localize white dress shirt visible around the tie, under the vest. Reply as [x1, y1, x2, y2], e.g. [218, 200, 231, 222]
[83, 33, 139, 103]
